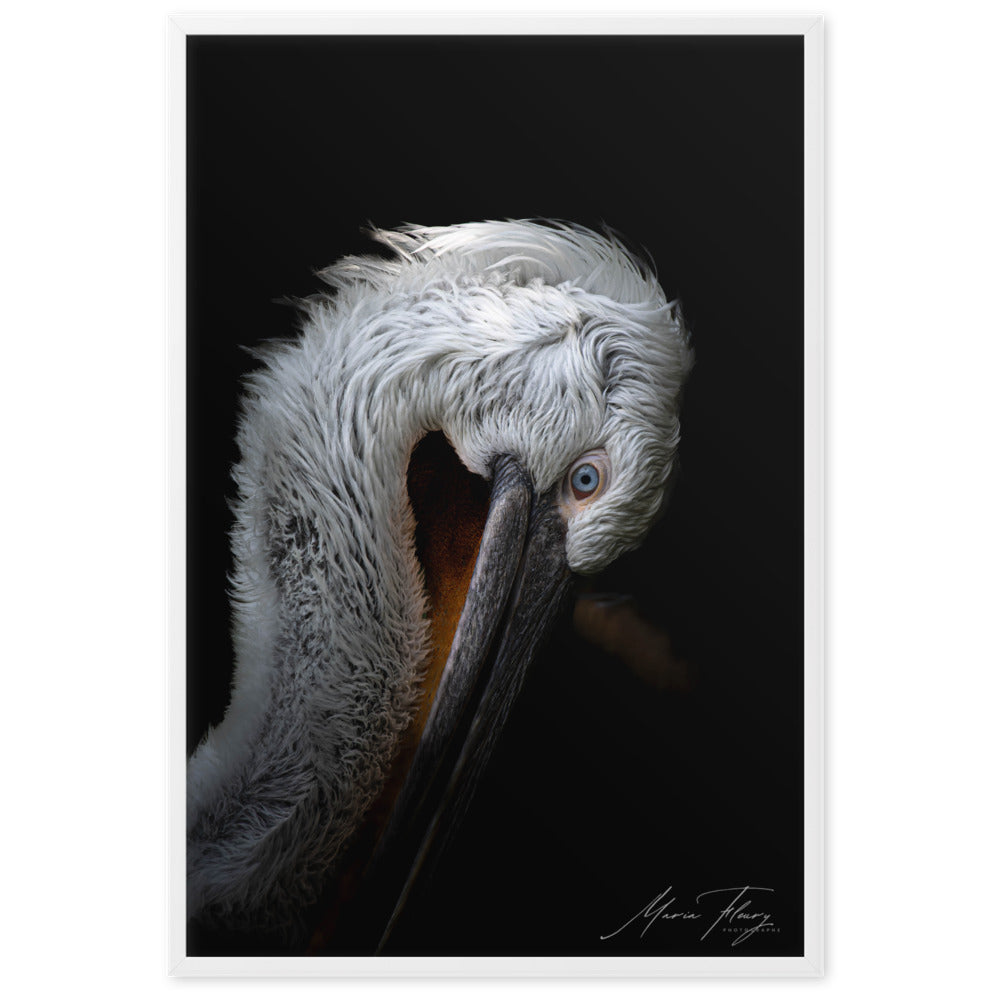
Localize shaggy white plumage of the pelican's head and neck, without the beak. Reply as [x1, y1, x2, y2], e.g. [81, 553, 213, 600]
[188, 215, 691, 936]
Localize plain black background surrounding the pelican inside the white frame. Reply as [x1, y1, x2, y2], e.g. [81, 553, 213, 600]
[187, 36, 803, 955]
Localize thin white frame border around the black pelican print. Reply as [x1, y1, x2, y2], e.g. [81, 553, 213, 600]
[166, 15, 825, 978]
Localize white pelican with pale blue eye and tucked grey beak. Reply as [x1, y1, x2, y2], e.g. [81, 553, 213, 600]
[187, 221, 692, 947]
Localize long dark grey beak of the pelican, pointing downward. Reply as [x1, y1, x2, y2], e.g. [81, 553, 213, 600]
[354, 457, 570, 951]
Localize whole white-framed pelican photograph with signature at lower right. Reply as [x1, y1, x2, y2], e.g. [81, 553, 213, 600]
[169, 17, 823, 976]
